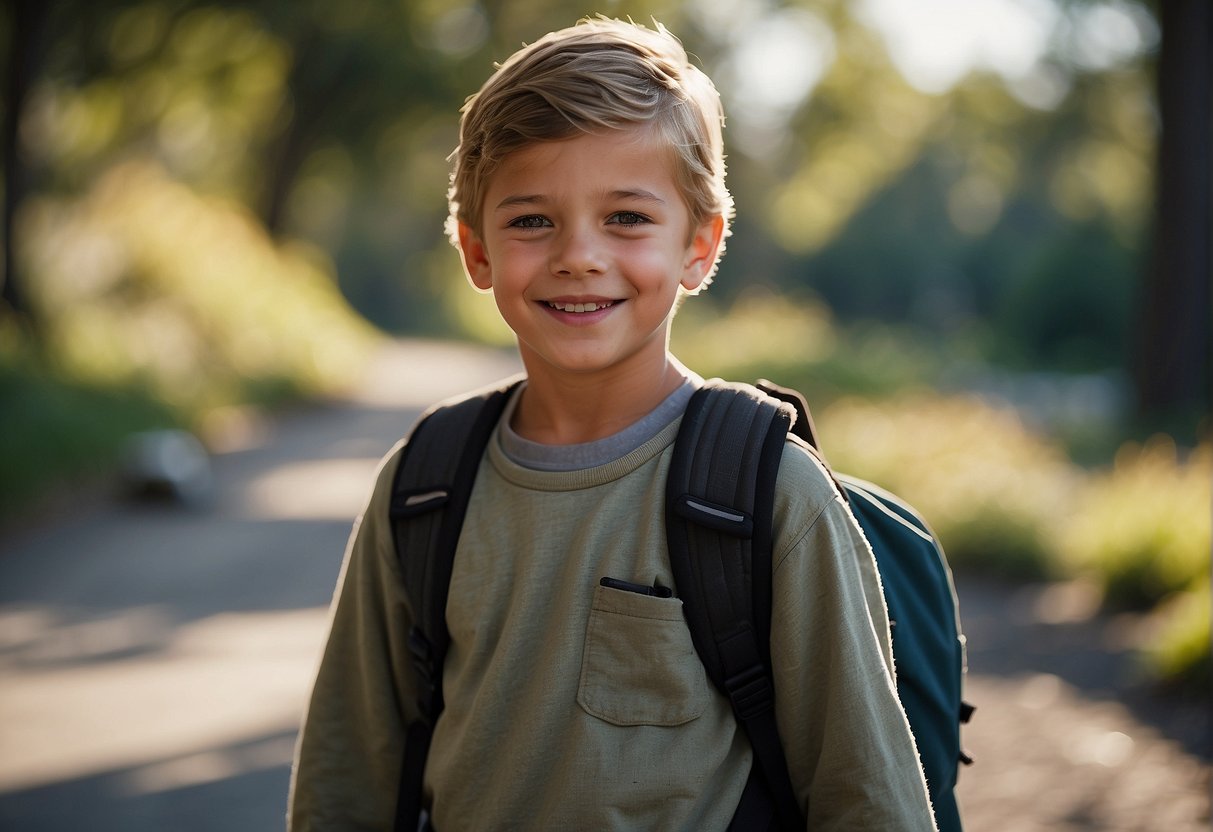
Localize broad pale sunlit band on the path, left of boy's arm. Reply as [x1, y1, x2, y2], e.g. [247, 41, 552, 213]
[0, 608, 328, 793]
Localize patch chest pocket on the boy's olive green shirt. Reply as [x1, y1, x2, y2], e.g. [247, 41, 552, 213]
[577, 586, 711, 725]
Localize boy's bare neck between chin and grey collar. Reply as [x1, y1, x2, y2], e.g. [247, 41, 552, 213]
[511, 353, 693, 445]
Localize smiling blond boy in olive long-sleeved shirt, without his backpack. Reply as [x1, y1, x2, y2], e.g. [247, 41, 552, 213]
[290, 14, 934, 832]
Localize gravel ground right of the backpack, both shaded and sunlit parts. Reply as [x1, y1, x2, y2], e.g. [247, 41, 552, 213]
[957, 576, 1213, 832]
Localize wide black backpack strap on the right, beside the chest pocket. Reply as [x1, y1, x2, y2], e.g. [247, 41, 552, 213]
[666, 380, 804, 830]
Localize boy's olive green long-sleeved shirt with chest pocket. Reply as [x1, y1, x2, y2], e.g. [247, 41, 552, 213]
[289, 400, 934, 832]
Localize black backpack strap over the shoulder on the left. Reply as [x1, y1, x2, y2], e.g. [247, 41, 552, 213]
[391, 378, 520, 832]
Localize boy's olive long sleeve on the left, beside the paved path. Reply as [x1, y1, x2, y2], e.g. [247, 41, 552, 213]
[287, 449, 414, 832]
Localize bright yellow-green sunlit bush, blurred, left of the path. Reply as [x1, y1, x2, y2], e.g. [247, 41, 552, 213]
[24, 164, 371, 414]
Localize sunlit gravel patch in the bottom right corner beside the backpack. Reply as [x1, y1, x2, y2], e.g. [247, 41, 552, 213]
[957, 668, 1209, 832]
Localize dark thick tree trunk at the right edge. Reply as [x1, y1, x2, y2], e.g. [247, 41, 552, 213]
[1134, 0, 1213, 429]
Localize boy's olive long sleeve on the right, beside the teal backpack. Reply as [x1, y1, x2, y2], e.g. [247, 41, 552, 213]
[771, 448, 935, 832]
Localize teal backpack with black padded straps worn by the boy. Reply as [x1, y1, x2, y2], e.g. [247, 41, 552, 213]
[391, 378, 973, 832]
